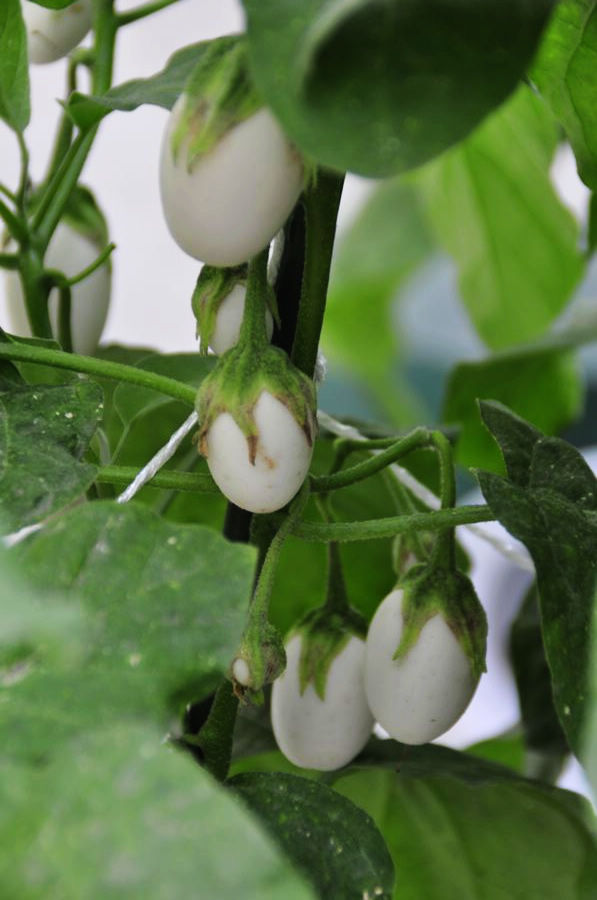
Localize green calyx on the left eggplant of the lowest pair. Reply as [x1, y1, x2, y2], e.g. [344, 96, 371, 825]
[289, 606, 367, 700]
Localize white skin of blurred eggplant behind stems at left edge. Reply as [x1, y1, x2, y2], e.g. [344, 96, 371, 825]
[5, 222, 110, 355]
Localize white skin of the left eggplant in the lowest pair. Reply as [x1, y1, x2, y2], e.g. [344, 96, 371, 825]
[271, 634, 373, 772]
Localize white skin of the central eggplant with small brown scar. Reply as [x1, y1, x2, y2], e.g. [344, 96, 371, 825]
[207, 391, 313, 513]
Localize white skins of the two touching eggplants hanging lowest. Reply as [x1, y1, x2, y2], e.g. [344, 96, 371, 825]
[271, 587, 479, 771]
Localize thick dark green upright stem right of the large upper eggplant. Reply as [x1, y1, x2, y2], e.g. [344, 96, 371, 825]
[292, 171, 344, 378]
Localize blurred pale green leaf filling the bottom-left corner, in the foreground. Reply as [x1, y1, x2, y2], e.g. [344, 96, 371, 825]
[0, 722, 314, 900]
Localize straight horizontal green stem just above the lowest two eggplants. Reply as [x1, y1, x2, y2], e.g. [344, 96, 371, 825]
[292, 506, 495, 542]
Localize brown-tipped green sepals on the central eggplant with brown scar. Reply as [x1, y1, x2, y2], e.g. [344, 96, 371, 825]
[195, 340, 317, 465]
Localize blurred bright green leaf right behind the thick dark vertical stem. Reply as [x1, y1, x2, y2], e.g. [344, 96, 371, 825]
[322, 180, 433, 421]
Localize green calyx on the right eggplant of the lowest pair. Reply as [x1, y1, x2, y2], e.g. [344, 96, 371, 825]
[394, 565, 487, 679]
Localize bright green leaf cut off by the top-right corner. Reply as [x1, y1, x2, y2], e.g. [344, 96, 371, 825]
[531, 0, 597, 190]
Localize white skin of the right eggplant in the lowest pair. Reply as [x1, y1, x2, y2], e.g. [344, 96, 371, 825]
[365, 590, 477, 744]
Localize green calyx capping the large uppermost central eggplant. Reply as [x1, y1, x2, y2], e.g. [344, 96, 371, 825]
[171, 35, 263, 172]
